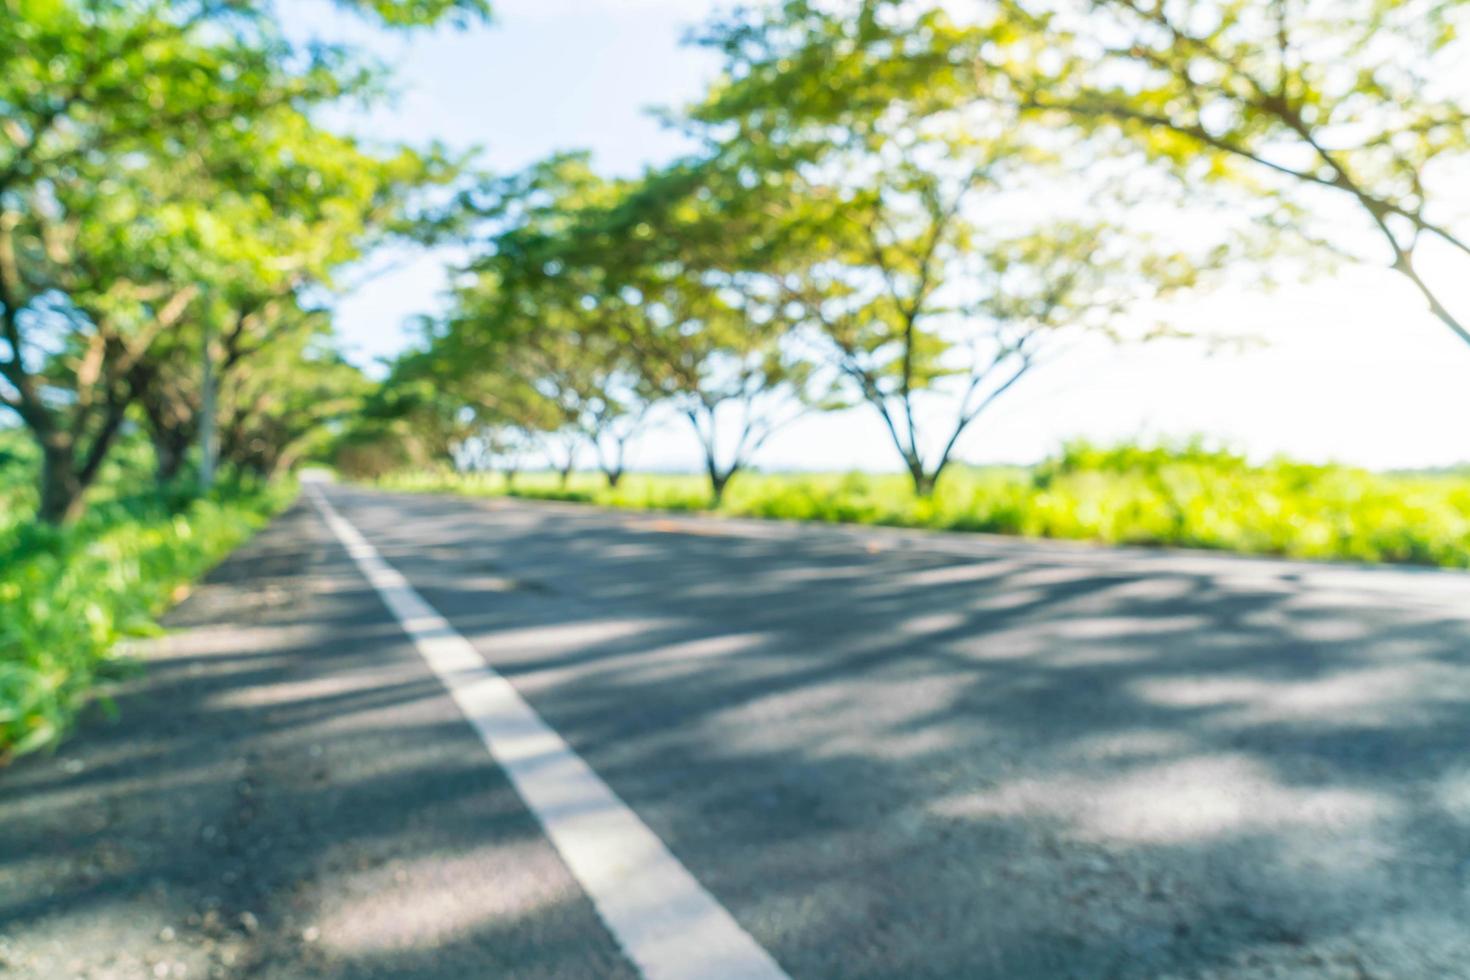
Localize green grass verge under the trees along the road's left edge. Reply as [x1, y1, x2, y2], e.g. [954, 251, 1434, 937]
[0, 432, 291, 761]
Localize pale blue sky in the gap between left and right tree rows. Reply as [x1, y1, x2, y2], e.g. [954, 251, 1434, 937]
[282, 0, 716, 361]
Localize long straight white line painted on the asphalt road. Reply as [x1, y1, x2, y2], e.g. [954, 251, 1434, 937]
[306, 485, 789, 980]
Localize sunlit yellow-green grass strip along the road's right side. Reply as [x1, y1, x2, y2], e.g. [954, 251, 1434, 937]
[376, 444, 1470, 567]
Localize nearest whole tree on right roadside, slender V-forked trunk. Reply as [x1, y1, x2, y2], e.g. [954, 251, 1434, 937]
[689, 3, 1210, 497]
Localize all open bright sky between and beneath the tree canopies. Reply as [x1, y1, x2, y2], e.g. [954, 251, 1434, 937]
[284, 0, 1470, 470]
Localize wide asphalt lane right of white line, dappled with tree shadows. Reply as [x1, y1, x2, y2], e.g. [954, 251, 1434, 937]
[344, 494, 1470, 977]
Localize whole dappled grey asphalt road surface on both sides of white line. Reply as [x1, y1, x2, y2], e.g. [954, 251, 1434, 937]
[0, 488, 1470, 980]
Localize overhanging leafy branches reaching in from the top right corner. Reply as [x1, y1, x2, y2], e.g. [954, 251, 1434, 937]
[782, 0, 1470, 352]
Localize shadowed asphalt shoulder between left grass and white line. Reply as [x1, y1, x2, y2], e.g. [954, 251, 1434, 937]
[0, 507, 632, 980]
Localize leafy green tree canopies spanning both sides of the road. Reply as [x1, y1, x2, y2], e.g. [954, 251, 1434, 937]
[0, 0, 1470, 522]
